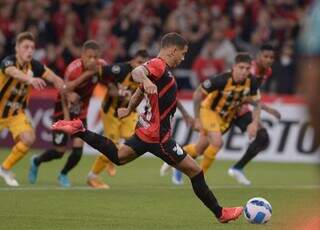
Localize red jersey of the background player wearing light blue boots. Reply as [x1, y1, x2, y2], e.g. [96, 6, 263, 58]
[53, 58, 106, 120]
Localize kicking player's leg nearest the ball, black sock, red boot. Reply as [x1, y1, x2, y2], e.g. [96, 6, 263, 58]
[158, 139, 242, 222]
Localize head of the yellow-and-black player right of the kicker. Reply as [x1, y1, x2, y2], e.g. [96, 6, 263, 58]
[232, 53, 252, 82]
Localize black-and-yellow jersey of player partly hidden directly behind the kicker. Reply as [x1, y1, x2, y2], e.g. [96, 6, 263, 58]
[102, 62, 139, 116]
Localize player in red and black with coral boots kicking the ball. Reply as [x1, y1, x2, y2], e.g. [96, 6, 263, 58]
[52, 33, 243, 223]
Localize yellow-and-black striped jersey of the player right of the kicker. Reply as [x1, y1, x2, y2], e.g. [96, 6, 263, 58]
[201, 72, 260, 123]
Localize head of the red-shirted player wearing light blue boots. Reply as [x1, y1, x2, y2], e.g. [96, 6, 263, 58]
[81, 40, 100, 69]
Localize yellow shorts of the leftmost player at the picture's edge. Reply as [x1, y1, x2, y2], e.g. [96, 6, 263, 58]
[0, 113, 33, 139]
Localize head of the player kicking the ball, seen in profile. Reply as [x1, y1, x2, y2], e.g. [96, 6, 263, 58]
[160, 32, 188, 67]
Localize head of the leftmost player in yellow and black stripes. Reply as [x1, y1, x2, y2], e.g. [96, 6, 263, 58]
[15, 32, 35, 62]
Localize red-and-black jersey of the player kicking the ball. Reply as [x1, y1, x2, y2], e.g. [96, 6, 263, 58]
[135, 58, 178, 143]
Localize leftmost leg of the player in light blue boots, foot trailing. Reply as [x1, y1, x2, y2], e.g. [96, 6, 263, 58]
[28, 131, 68, 184]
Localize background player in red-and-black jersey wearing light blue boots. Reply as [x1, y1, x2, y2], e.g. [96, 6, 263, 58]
[29, 40, 106, 187]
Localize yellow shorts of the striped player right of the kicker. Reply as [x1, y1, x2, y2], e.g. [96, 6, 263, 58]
[200, 108, 230, 133]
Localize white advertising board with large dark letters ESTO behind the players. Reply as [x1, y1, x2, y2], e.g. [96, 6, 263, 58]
[85, 98, 320, 163]
